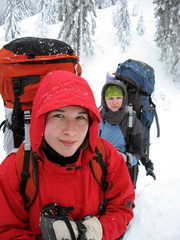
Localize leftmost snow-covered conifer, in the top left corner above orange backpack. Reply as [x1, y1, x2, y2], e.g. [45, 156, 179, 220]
[4, 0, 20, 41]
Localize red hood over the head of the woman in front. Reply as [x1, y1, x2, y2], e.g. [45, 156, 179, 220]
[30, 71, 100, 152]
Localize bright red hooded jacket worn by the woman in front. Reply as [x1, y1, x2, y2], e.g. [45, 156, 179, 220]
[0, 71, 135, 240]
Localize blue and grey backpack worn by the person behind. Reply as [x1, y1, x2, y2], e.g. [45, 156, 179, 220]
[115, 59, 160, 162]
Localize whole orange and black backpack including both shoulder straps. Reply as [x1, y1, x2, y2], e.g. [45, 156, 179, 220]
[0, 37, 108, 216]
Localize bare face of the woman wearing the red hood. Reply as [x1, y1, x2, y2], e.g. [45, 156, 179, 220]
[44, 106, 89, 157]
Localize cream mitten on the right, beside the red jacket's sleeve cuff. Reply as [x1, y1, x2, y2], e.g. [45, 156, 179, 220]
[82, 216, 102, 240]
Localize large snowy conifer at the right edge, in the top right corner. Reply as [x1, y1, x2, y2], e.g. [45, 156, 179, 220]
[154, 0, 180, 81]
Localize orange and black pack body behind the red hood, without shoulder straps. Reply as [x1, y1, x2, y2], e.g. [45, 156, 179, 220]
[0, 37, 81, 152]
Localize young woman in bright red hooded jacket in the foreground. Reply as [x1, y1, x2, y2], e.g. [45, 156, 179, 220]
[0, 71, 135, 240]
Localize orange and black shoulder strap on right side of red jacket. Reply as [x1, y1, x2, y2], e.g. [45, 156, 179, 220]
[89, 138, 109, 215]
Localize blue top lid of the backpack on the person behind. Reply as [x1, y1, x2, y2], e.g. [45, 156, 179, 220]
[116, 59, 155, 94]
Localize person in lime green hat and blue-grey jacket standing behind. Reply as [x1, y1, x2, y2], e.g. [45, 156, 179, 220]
[99, 78, 155, 188]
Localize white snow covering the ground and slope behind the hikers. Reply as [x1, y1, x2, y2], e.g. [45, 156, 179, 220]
[0, 0, 180, 240]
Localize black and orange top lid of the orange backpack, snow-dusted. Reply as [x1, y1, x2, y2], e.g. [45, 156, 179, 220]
[0, 37, 78, 63]
